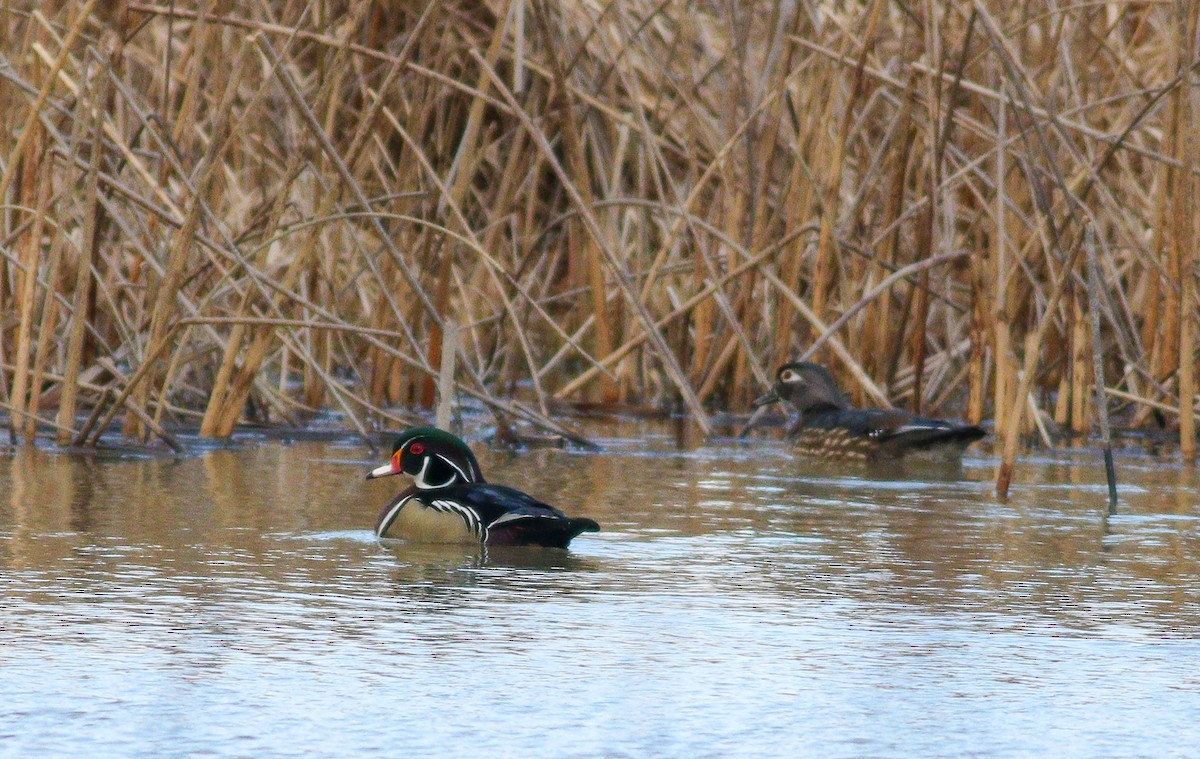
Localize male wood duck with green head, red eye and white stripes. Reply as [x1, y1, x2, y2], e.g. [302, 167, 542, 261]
[367, 428, 600, 548]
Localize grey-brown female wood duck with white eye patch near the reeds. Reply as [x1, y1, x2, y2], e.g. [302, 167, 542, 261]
[754, 361, 986, 461]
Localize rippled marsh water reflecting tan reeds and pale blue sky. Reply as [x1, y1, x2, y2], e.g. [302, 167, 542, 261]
[0, 422, 1200, 757]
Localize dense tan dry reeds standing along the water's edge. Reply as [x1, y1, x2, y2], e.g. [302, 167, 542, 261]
[0, 0, 1200, 488]
